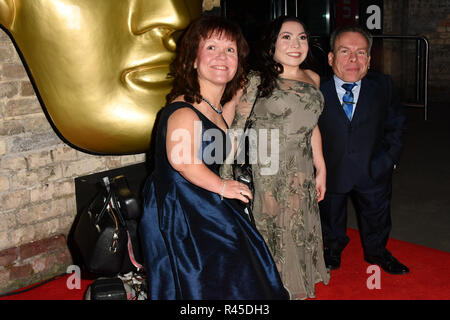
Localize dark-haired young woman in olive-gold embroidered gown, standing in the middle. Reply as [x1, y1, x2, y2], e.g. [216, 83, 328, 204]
[221, 17, 330, 299]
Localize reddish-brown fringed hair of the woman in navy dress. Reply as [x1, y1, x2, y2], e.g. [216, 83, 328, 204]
[166, 15, 249, 103]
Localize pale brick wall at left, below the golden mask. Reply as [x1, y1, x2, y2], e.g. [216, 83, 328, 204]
[0, 30, 145, 293]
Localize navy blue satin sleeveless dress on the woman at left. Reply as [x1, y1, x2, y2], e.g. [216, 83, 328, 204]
[140, 102, 289, 300]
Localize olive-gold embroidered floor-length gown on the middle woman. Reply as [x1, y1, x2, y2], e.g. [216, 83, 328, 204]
[221, 73, 330, 299]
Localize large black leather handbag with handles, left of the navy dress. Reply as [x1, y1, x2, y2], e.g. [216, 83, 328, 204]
[74, 175, 142, 275]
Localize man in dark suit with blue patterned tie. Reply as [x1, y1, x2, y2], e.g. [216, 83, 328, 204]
[319, 27, 409, 274]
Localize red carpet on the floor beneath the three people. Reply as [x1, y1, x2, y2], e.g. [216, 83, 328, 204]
[0, 229, 450, 300]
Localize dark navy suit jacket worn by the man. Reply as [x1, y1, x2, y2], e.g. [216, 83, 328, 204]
[319, 72, 405, 193]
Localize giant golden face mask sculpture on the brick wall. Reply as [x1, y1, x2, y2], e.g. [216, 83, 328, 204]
[0, 0, 202, 154]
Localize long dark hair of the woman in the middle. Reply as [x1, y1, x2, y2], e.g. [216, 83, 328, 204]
[257, 16, 311, 97]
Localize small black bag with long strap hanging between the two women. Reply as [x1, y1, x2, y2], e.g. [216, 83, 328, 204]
[232, 90, 259, 224]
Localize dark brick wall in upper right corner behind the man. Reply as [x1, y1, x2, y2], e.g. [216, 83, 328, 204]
[383, 0, 450, 103]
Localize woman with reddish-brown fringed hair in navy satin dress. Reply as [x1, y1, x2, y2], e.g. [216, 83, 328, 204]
[140, 16, 288, 300]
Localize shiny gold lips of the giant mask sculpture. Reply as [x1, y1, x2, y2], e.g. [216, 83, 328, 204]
[122, 62, 172, 90]
